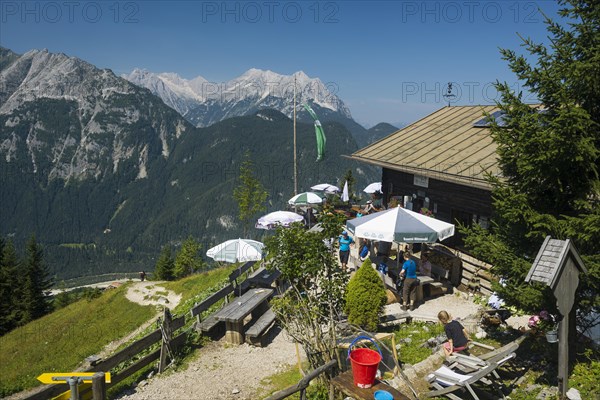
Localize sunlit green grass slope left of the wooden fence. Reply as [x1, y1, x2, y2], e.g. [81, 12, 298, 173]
[0, 265, 236, 398]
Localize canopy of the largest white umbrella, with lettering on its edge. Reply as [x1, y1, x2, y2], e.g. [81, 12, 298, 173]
[346, 207, 454, 243]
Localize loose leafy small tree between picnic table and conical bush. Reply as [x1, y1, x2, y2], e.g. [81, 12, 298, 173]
[265, 208, 348, 380]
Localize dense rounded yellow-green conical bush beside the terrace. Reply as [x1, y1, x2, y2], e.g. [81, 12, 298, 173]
[346, 260, 387, 332]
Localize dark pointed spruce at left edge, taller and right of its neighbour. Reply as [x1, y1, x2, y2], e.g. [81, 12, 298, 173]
[22, 236, 52, 323]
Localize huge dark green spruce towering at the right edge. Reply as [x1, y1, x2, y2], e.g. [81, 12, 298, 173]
[465, 0, 600, 322]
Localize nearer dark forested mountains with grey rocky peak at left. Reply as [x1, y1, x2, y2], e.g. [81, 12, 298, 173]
[0, 48, 380, 279]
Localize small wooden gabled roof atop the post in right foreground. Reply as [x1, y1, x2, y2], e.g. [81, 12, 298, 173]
[525, 236, 587, 288]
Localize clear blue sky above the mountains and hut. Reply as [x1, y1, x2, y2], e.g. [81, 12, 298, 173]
[0, 0, 558, 125]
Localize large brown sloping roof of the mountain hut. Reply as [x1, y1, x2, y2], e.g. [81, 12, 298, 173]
[350, 105, 500, 189]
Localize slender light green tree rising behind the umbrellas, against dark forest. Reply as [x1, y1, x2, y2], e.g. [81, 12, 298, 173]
[233, 150, 267, 237]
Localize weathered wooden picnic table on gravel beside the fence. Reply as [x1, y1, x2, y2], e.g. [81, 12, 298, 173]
[215, 289, 273, 344]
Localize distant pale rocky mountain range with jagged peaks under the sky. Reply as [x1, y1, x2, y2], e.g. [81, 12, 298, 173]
[122, 68, 397, 147]
